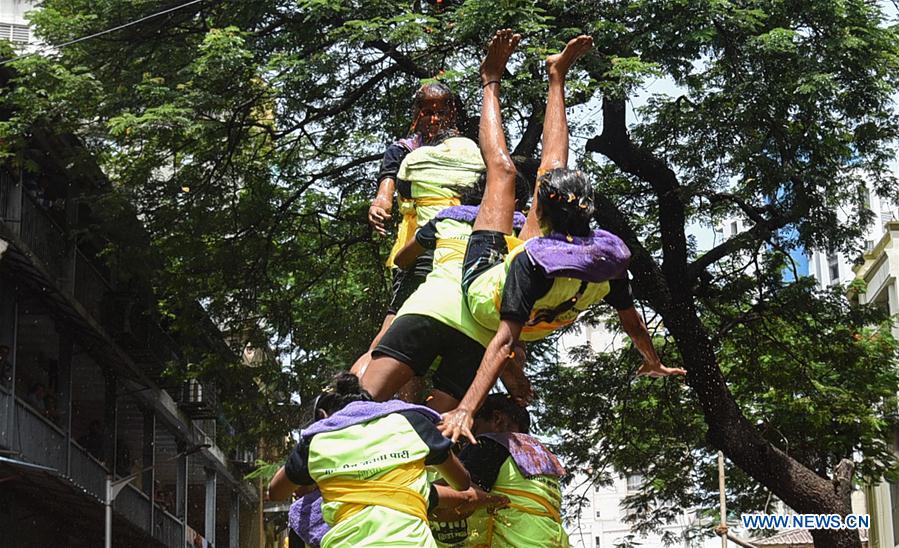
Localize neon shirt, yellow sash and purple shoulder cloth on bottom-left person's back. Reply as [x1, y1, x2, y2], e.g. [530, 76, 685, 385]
[303, 402, 446, 547]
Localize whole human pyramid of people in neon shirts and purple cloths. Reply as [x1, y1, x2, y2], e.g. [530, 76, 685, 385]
[269, 29, 685, 547]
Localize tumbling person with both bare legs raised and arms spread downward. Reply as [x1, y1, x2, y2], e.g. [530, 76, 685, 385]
[440, 30, 685, 442]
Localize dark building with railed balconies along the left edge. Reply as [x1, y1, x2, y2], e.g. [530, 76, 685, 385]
[0, 131, 259, 548]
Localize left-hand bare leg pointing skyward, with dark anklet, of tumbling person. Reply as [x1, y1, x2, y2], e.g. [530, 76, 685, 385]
[474, 29, 521, 234]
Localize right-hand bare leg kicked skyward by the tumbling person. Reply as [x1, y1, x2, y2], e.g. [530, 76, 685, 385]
[519, 35, 593, 240]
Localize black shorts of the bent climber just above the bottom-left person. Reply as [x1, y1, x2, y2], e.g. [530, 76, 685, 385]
[372, 314, 485, 400]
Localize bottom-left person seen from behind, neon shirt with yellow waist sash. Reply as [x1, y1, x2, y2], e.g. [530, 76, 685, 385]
[268, 373, 469, 548]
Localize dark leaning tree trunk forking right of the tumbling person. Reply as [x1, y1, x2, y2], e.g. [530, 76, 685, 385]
[587, 97, 861, 548]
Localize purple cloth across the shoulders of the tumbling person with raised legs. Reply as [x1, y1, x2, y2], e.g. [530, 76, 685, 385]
[525, 230, 631, 283]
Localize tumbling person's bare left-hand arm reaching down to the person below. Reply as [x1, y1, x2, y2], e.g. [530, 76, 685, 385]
[437, 320, 523, 443]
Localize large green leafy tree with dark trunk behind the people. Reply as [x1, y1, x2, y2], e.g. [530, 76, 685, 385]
[0, 0, 899, 546]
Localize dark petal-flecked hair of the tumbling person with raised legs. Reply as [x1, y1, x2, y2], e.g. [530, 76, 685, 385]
[537, 168, 594, 236]
